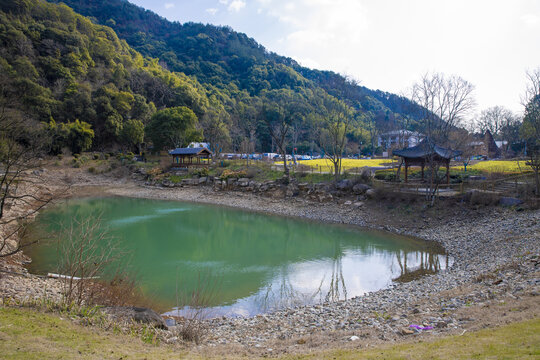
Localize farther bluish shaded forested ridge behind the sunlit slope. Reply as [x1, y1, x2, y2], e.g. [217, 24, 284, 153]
[47, 0, 421, 153]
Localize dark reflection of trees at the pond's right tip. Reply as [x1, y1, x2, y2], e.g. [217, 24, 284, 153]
[393, 250, 449, 282]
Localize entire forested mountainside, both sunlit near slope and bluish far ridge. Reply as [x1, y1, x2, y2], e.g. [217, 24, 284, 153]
[0, 0, 428, 153]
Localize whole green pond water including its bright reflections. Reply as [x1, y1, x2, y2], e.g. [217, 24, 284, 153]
[26, 198, 449, 316]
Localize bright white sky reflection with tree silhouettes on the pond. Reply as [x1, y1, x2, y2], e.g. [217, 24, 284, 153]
[167, 247, 451, 317]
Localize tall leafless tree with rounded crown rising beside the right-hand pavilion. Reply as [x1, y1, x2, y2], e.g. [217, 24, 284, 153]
[411, 73, 475, 204]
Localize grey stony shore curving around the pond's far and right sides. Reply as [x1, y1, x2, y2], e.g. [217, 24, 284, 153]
[0, 171, 540, 355]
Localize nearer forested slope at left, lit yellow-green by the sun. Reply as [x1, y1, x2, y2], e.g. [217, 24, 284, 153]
[0, 1, 209, 150]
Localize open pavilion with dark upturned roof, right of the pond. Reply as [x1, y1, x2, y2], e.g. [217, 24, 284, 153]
[393, 139, 461, 184]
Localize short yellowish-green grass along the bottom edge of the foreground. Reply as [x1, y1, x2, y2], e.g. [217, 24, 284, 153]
[0, 307, 540, 359]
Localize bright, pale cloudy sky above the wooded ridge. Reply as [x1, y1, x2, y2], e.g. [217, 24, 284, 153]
[130, 0, 540, 112]
